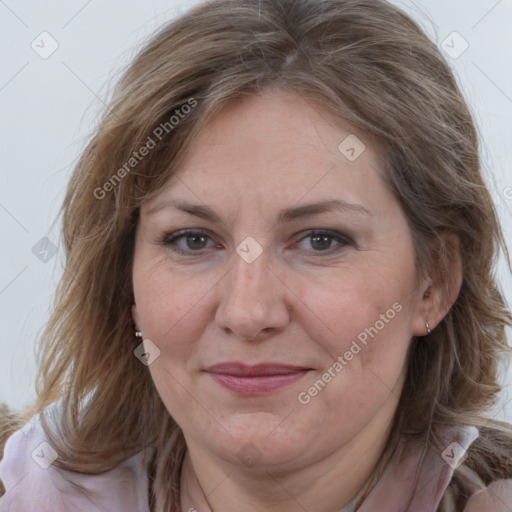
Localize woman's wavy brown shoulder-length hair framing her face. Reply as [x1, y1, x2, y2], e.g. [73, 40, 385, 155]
[1, 0, 512, 511]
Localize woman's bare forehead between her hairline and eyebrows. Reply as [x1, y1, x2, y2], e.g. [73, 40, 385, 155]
[140, 90, 388, 216]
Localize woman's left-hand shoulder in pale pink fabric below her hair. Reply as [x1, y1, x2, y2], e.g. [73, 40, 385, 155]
[0, 408, 149, 512]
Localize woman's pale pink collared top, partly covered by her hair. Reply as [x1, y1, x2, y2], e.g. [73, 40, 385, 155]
[0, 416, 512, 512]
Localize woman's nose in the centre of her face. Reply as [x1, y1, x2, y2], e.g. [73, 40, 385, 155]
[215, 254, 290, 340]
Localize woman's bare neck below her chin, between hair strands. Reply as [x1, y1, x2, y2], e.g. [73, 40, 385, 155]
[181, 412, 389, 512]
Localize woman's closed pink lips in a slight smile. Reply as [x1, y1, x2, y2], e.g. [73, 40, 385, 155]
[206, 362, 310, 395]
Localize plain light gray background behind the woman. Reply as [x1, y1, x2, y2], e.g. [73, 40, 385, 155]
[0, 0, 512, 421]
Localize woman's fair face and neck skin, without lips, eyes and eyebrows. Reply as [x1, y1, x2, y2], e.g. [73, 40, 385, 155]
[132, 90, 460, 512]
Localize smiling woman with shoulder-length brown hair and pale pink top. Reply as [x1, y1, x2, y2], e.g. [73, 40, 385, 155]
[0, 0, 512, 512]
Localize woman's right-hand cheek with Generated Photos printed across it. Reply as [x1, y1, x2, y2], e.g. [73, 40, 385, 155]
[288, 272, 410, 442]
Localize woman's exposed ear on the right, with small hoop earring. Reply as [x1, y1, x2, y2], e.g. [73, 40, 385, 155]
[412, 232, 463, 336]
